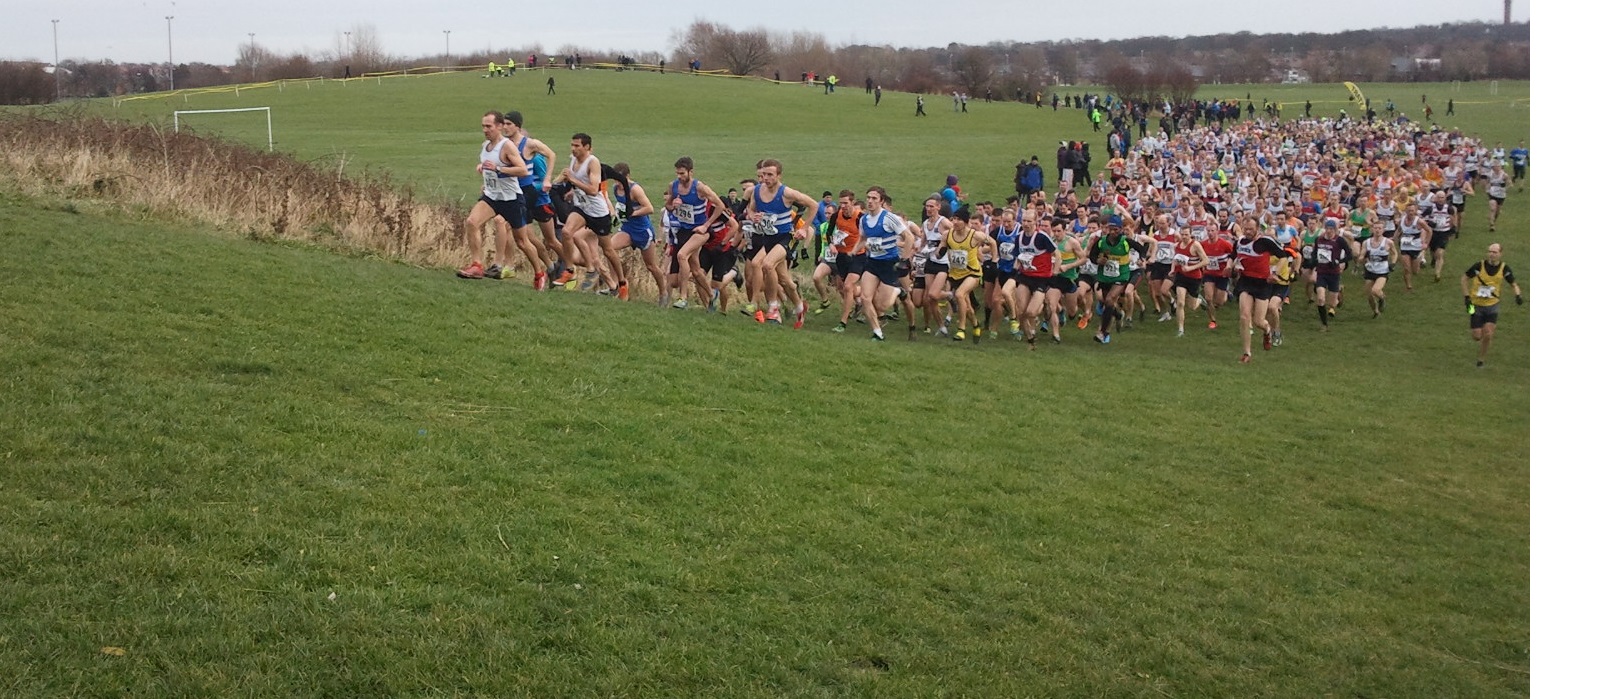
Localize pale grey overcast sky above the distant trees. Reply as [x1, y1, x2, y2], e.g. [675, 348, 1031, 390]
[0, 0, 1531, 64]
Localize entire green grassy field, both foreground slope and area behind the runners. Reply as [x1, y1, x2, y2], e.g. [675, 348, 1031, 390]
[0, 72, 1531, 697]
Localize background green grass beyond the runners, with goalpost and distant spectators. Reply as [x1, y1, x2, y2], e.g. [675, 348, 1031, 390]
[96, 70, 1530, 209]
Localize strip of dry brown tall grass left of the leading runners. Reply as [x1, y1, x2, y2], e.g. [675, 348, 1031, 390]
[0, 110, 466, 267]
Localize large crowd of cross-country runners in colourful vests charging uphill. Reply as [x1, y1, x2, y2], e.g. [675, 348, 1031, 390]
[458, 106, 1526, 366]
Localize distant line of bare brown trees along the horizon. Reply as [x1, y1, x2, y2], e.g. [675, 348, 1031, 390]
[0, 19, 1531, 104]
